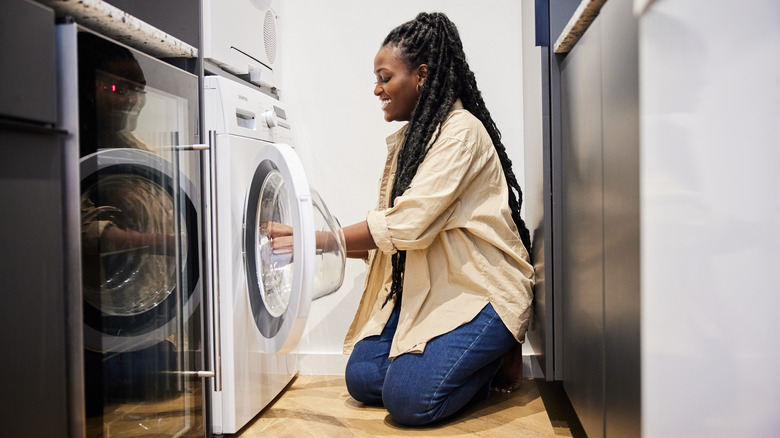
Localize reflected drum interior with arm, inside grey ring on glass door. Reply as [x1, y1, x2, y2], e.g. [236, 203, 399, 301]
[81, 174, 180, 316]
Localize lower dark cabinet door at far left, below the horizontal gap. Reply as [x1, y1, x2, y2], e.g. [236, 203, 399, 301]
[0, 121, 68, 437]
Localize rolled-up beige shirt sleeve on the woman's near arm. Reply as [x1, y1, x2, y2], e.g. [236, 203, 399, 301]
[366, 133, 475, 253]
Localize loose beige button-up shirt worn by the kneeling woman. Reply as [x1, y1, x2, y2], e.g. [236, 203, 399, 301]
[344, 101, 534, 358]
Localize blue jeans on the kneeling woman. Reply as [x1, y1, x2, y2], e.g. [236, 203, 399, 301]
[345, 304, 517, 426]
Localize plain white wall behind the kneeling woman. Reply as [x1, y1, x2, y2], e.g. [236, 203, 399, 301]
[278, 0, 523, 375]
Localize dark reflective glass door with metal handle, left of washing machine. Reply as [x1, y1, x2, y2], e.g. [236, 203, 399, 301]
[78, 31, 204, 437]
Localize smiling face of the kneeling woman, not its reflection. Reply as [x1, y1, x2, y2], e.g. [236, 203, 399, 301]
[374, 46, 427, 122]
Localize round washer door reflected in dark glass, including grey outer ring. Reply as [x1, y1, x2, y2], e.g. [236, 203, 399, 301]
[80, 149, 200, 352]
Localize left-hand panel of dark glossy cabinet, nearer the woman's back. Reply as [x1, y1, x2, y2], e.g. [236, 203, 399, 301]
[561, 21, 604, 437]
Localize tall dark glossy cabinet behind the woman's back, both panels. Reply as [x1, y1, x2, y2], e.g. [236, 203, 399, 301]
[526, 0, 641, 437]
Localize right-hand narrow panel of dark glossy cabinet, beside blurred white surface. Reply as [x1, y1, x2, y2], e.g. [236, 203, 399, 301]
[599, 1, 641, 438]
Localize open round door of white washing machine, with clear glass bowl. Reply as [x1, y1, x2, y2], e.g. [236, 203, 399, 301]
[243, 144, 346, 353]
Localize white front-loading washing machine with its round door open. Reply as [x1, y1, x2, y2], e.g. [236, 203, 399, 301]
[204, 76, 346, 435]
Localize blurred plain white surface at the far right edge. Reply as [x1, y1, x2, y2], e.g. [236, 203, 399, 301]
[639, 0, 780, 438]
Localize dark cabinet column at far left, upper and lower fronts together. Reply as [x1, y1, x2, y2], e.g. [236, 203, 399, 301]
[0, 0, 83, 437]
